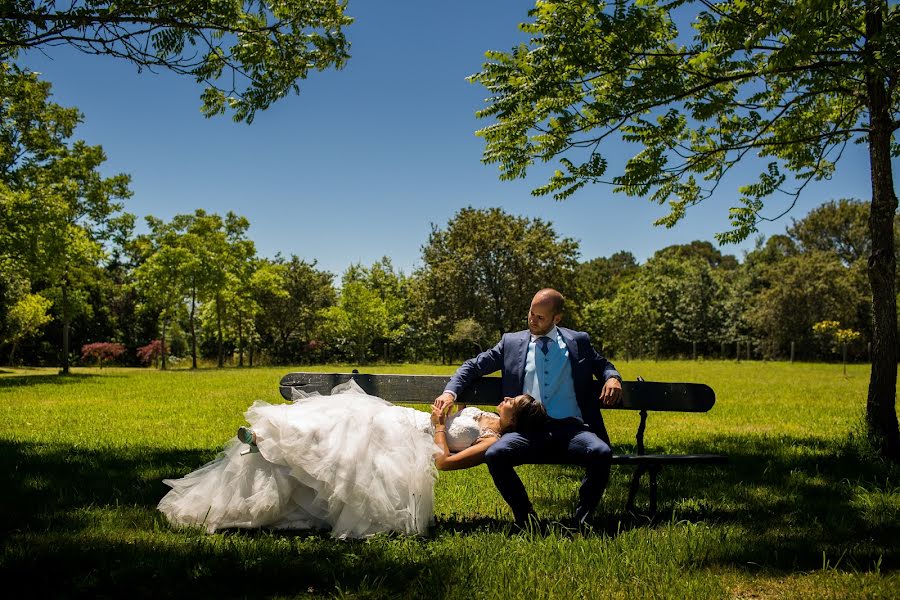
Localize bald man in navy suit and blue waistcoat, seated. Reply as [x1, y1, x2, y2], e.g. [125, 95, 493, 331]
[434, 288, 622, 526]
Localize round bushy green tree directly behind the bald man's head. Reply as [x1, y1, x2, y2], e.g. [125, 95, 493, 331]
[419, 208, 578, 340]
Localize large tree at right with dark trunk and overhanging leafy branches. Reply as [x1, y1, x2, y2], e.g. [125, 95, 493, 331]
[471, 0, 900, 461]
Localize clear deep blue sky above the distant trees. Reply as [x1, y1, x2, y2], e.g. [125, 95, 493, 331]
[20, 0, 884, 275]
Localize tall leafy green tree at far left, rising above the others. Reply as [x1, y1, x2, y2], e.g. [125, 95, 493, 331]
[0, 63, 133, 373]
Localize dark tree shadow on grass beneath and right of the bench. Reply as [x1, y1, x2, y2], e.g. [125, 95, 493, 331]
[536, 436, 900, 571]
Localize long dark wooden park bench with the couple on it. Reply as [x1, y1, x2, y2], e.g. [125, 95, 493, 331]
[279, 369, 728, 514]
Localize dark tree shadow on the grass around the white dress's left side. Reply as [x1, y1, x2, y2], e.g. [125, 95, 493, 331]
[0, 440, 464, 598]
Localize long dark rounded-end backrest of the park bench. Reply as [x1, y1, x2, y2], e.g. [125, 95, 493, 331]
[280, 373, 716, 412]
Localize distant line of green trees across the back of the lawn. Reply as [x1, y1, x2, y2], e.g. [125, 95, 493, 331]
[0, 64, 884, 371]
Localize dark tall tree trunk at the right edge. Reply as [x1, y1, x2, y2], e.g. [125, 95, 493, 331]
[866, 0, 900, 462]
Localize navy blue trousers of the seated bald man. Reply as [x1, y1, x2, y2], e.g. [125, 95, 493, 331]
[485, 419, 612, 522]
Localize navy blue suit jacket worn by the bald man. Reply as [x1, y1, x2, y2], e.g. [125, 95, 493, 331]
[447, 327, 621, 444]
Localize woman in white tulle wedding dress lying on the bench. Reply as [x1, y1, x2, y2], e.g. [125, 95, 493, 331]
[158, 380, 546, 538]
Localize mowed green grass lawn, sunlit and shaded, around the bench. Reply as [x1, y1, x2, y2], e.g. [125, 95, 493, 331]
[0, 361, 900, 598]
